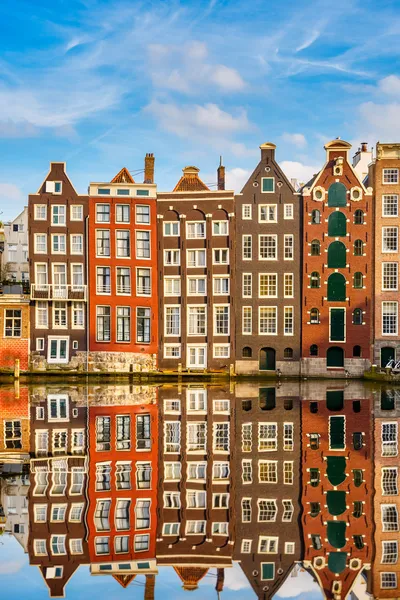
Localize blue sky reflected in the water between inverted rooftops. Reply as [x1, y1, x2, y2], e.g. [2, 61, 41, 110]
[0, 535, 322, 600]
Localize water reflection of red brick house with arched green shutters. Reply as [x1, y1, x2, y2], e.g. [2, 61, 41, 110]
[301, 382, 374, 600]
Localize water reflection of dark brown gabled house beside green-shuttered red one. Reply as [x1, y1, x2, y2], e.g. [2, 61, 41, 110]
[234, 382, 303, 600]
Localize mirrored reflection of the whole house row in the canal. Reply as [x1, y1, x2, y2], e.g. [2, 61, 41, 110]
[0, 381, 400, 600]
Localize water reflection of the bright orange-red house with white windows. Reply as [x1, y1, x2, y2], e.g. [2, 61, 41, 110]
[87, 386, 158, 598]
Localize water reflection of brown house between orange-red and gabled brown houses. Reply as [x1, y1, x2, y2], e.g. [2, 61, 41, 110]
[156, 384, 236, 591]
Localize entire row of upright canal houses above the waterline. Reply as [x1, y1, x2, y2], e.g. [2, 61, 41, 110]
[14, 139, 400, 376]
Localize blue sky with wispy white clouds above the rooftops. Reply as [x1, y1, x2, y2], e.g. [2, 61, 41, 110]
[0, 0, 400, 219]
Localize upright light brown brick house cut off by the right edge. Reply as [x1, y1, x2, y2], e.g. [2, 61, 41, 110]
[369, 143, 400, 367]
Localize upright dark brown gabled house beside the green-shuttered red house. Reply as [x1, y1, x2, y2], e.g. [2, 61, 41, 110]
[235, 143, 302, 375]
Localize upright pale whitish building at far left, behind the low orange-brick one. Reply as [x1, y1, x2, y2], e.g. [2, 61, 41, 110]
[2, 206, 29, 284]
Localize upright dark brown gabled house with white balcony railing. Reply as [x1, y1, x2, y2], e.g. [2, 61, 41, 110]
[28, 163, 88, 370]
